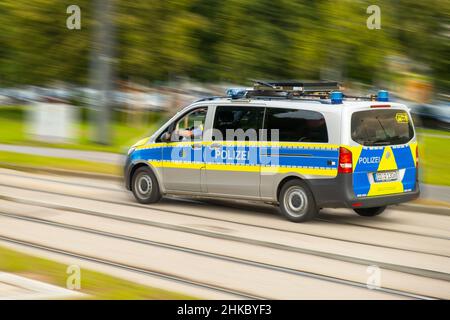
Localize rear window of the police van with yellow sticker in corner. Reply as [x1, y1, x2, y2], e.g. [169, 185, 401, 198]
[352, 109, 414, 146]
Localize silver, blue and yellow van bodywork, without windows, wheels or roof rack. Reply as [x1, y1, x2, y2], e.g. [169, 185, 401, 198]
[125, 98, 419, 221]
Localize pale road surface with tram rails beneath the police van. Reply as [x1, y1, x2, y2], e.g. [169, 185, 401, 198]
[0, 169, 450, 299]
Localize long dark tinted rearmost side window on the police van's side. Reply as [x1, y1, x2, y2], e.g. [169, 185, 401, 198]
[265, 108, 328, 142]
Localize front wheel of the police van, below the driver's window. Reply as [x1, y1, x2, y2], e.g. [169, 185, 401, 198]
[131, 167, 161, 204]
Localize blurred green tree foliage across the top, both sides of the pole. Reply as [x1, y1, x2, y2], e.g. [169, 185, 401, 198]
[0, 0, 450, 92]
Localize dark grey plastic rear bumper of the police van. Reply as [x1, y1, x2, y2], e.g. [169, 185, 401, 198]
[308, 174, 420, 208]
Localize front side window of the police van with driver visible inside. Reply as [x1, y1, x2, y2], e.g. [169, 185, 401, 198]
[157, 107, 208, 142]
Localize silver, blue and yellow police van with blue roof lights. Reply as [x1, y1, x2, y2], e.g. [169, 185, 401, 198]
[125, 81, 419, 222]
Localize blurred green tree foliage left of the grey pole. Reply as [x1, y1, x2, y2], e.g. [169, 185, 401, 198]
[0, 0, 92, 85]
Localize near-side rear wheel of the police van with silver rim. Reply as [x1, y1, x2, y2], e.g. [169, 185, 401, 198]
[279, 180, 318, 222]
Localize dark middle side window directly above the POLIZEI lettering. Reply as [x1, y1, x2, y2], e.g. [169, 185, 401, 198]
[213, 106, 264, 141]
